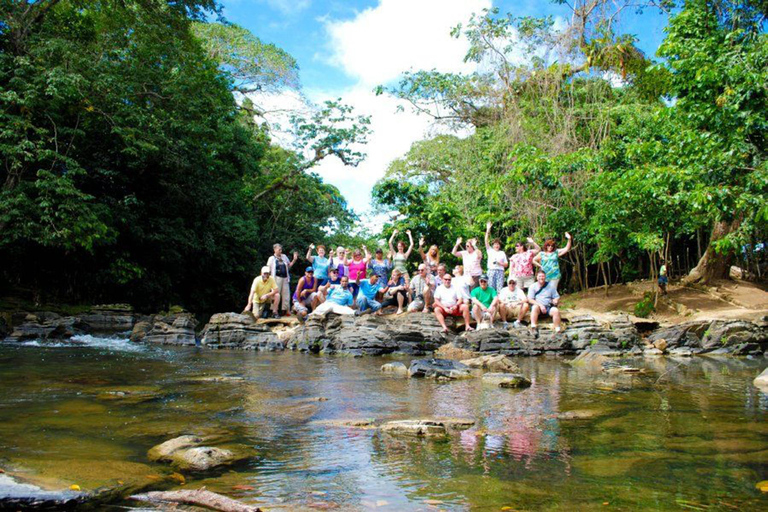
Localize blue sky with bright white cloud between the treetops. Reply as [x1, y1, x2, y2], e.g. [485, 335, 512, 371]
[222, 0, 666, 220]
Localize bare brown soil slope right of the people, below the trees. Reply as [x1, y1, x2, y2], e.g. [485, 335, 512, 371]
[561, 280, 768, 324]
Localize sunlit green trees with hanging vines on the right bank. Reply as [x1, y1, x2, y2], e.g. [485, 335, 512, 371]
[374, 0, 768, 291]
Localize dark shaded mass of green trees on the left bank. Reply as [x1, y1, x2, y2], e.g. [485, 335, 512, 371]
[0, 0, 362, 312]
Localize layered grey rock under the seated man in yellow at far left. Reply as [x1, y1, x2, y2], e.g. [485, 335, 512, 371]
[201, 313, 285, 350]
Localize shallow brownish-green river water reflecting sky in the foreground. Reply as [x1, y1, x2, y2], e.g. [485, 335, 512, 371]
[0, 337, 768, 511]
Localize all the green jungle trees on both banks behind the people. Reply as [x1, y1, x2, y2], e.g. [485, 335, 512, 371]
[0, 0, 768, 311]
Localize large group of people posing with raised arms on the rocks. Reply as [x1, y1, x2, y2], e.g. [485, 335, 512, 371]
[245, 222, 573, 332]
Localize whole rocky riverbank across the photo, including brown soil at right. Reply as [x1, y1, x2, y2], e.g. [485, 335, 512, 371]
[0, 282, 768, 357]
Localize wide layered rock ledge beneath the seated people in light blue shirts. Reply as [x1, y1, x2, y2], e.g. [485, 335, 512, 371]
[288, 313, 445, 355]
